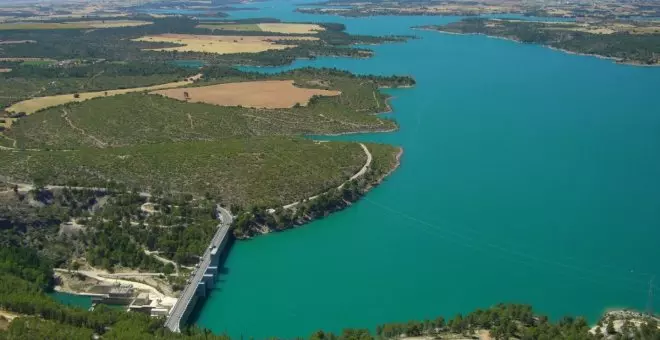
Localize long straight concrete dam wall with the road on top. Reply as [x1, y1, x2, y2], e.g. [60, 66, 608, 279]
[165, 206, 233, 332]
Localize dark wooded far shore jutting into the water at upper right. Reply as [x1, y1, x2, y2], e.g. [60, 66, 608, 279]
[426, 18, 660, 65]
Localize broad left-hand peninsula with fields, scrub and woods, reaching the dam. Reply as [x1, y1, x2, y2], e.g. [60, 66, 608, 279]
[0, 0, 415, 322]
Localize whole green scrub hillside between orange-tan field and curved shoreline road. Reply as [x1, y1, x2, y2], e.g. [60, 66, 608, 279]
[0, 70, 408, 206]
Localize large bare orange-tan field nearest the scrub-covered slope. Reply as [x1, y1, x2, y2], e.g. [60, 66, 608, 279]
[152, 80, 341, 109]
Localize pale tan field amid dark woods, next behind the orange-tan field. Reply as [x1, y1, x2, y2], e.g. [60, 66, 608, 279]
[135, 34, 318, 54]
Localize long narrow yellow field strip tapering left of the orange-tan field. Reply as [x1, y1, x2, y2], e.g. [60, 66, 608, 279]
[6, 74, 201, 114]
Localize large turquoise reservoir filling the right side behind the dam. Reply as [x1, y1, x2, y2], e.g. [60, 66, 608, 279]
[191, 1, 660, 339]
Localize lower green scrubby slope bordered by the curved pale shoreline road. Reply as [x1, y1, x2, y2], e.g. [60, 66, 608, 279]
[0, 137, 366, 204]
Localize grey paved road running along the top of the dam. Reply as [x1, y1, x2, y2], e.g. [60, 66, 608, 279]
[165, 205, 233, 332]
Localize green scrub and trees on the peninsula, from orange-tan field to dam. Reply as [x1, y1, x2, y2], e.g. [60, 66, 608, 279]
[0, 66, 414, 282]
